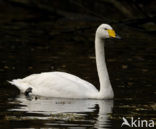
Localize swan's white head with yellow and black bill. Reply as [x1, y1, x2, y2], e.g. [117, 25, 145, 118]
[96, 24, 119, 39]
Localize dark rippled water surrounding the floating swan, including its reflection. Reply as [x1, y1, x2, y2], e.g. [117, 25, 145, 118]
[0, 1, 156, 129]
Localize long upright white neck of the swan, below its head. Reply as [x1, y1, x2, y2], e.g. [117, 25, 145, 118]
[95, 35, 114, 99]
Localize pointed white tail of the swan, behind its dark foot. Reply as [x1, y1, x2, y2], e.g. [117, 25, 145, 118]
[8, 79, 31, 93]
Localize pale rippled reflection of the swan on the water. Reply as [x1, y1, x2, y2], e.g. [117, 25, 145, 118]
[10, 95, 113, 128]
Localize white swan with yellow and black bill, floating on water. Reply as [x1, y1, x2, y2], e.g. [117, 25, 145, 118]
[10, 24, 117, 99]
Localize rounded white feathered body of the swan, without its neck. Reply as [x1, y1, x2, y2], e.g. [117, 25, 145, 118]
[9, 72, 98, 98]
